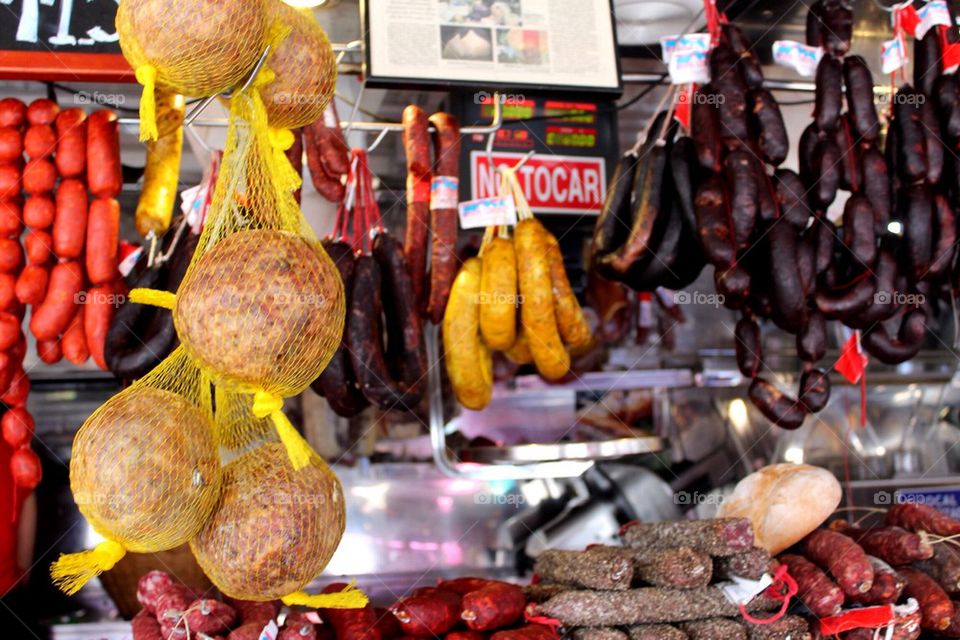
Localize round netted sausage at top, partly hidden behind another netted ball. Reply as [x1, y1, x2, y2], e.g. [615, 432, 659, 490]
[260, 0, 337, 129]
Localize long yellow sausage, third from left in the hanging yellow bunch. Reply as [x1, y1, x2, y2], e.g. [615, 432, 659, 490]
[514, 218, 570, 380]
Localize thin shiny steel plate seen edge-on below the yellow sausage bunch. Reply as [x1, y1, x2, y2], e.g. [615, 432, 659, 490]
[457, 436, 664, 464]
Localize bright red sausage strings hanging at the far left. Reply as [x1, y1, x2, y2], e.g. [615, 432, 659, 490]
[0, 98, 125, 488]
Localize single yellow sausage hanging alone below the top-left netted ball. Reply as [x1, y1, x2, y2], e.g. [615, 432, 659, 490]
[136, 91, 186, 236]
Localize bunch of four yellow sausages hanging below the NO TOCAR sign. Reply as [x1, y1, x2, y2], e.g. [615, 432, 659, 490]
[443, 206, 593, 411]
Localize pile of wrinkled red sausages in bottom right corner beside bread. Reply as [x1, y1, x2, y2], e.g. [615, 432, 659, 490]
[778, 503, 960, 640]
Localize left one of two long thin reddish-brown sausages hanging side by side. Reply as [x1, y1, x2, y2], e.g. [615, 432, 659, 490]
[402, 105, 432, 309]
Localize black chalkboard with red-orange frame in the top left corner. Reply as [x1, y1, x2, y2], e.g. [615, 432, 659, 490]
[0, 0, 133, 81]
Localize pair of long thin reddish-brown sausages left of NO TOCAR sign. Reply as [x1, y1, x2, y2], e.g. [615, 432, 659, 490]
[402, 105, 460, 324]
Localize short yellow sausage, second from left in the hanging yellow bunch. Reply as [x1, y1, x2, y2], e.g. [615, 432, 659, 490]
[480, 237, 517, 351]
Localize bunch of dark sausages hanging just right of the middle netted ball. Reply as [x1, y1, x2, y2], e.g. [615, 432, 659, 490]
[311, 232, 427, 417]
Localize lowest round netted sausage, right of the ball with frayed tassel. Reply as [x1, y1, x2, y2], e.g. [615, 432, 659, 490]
[190, 443, 348, 606]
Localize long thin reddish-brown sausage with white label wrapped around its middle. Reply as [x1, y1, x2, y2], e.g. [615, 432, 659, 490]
[427, 113, 460, 324]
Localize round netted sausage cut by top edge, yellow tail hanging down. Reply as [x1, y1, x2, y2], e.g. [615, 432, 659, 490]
[117, 0, 272, 140]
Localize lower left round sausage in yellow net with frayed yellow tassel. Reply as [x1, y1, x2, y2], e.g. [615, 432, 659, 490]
[51, 349, 220, 594]
